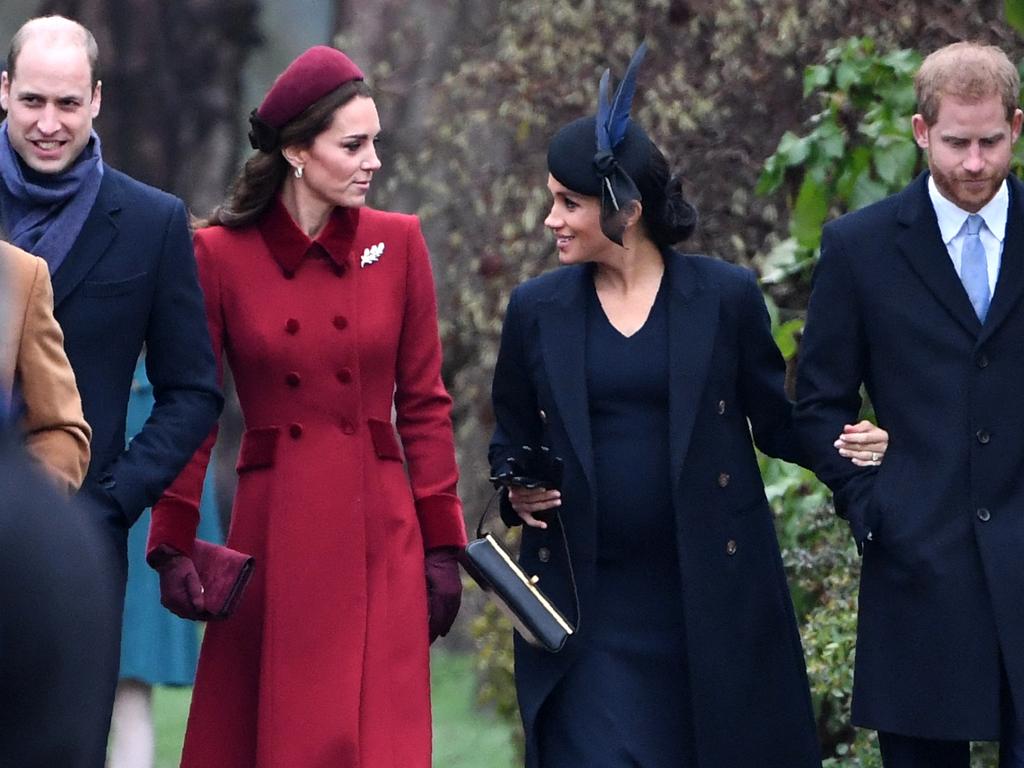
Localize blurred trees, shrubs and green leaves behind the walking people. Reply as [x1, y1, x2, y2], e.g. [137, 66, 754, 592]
[0, 0, 1024, 768]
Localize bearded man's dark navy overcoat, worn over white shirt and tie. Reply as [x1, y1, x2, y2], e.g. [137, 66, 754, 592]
[797, 172, 1024, 739]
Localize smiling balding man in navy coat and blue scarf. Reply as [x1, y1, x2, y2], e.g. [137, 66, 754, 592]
[0, 16, 222, 768]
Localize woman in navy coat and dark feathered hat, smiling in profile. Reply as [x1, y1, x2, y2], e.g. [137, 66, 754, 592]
[490, 45, 887, 768]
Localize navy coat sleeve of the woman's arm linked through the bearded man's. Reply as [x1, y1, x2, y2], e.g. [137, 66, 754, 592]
[739, 273, 806, 466]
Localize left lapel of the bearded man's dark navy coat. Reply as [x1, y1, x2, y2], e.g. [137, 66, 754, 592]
[896, 173, 981, 336]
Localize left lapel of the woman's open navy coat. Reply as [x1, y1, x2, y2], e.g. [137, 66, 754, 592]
[539, 268, 595, 489]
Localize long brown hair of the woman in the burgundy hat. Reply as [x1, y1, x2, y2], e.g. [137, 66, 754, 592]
[199, 80, 372, 229]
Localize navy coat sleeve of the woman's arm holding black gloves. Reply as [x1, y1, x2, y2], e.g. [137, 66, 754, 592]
[487, 289, 544, 525]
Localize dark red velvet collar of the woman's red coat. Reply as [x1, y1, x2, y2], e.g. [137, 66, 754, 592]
[259, 198, 359, 274]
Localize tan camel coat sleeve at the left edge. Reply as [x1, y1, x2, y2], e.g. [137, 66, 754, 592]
[14, 253, 92, 493]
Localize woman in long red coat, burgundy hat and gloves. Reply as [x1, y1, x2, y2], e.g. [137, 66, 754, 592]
[150, 46, 466, 768]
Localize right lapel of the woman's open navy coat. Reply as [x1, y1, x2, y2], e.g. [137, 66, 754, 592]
[666, 252, 720, 483]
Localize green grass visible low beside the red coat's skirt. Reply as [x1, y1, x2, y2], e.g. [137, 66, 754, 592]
[153, 650, 515, 768]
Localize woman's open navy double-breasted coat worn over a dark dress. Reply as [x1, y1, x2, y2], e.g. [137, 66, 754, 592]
[489, 250, 819, 768]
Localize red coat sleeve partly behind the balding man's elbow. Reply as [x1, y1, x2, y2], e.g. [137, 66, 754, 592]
[146, 232, 224, 556]
